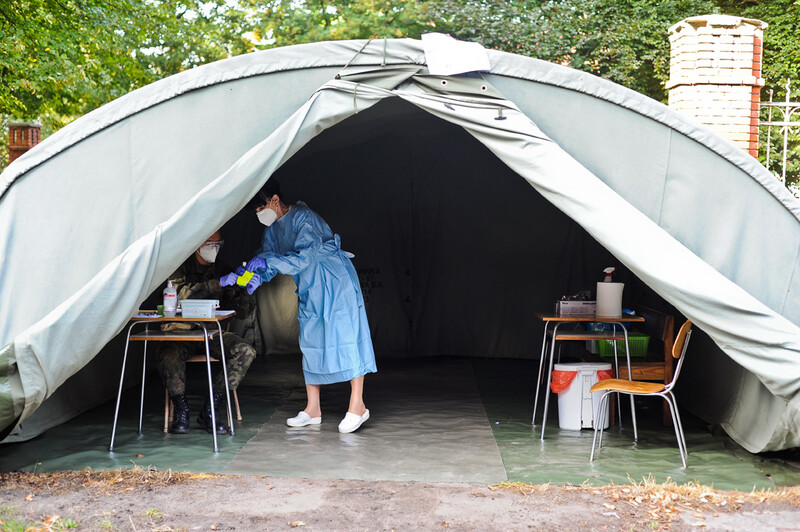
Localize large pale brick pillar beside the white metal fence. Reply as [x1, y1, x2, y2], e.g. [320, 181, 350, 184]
[667, 15, 767, 157]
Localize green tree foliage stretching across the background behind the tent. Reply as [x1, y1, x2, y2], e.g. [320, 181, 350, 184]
[0, 0, 800, 178]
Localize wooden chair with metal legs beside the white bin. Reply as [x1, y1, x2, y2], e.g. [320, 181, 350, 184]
[589, 320, 692, 468]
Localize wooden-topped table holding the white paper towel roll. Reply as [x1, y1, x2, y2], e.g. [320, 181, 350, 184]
[531, 312, 644, 440]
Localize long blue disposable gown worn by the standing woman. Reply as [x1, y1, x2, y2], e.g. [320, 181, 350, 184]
[256, 202, 377, 384]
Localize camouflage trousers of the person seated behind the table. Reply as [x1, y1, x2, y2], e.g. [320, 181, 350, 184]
[156, 332, 256, 397]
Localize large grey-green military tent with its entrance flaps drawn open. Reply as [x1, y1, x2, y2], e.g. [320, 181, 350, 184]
[0, 40, 800, 452]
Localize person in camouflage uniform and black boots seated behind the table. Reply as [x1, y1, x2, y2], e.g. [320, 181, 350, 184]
[156, 231, 256, 434]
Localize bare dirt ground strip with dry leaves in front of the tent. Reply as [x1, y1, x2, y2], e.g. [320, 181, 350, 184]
[0, 469, 800, 532]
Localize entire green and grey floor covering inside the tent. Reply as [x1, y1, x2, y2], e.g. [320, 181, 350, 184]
[0, 355, 800, 491]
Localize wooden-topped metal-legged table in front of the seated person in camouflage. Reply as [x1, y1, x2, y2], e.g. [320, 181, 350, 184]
[108, 310, 236, 452]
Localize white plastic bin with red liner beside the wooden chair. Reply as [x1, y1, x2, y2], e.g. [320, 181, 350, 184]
[553, 362, 611, 430]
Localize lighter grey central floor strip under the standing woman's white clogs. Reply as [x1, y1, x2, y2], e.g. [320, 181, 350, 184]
[223, 359, 506, 484]
